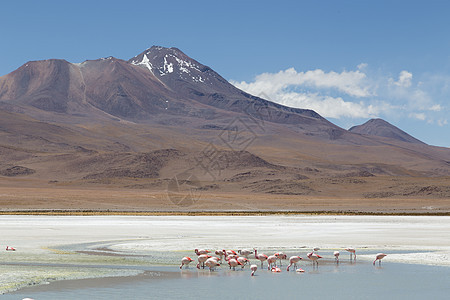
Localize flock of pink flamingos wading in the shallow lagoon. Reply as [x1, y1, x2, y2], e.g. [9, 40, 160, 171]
[180, 248, 386, 276]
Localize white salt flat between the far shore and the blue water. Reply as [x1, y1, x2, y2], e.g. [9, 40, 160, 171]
[0, 216, 450, 296]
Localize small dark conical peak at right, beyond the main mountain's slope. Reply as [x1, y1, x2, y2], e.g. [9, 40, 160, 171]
[348, 119, 425, 144]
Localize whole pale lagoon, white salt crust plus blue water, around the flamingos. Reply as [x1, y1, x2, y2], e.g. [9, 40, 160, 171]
[0, 216, 450, 299]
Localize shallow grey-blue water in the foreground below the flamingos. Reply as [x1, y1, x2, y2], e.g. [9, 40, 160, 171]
[7, 260, 450, 299]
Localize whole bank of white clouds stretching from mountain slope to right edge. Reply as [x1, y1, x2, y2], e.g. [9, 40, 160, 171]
[231, 63, 448, 126]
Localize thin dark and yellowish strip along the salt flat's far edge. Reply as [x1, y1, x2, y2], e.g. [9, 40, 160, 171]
[0, 209, 450, 217]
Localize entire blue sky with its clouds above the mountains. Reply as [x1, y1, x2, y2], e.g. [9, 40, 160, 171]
[0, 0, 450, 147]
